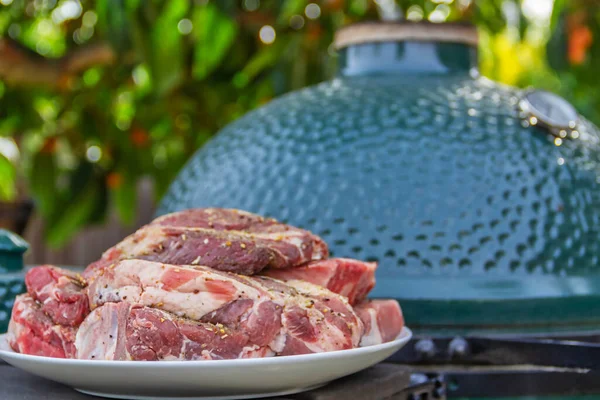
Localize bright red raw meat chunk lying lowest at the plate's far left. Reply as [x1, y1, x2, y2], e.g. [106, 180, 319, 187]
[7, 294, 77, 358]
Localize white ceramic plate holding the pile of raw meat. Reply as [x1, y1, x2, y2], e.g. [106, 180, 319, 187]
[0, 328, 412, 400]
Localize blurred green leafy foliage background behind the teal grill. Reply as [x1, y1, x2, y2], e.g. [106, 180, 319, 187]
[0, 0, 600, 246]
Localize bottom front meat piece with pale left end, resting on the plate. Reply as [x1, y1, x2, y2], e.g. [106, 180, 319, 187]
[75, 302, 274, 361]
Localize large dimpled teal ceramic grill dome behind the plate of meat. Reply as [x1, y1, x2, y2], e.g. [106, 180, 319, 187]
[159, 24, 600, 332]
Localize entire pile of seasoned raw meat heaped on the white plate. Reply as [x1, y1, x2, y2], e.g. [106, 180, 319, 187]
[8, 209, 404, 360]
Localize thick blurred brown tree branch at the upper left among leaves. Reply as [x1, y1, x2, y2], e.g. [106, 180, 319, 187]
[0, 38, 116, 90]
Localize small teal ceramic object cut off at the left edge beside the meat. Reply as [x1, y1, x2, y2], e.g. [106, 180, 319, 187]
[0, 229, 29, 333]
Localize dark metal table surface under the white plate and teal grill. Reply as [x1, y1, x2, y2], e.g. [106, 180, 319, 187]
[9, 337, 600, 400]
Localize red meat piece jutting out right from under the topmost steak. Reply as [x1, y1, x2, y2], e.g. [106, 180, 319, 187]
[262, 258, 377, 304]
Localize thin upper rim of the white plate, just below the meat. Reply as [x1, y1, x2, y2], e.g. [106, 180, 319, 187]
[0, 326, 413, 368]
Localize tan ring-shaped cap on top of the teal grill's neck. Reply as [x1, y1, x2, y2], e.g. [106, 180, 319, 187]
[334, 21, 479, 50]
